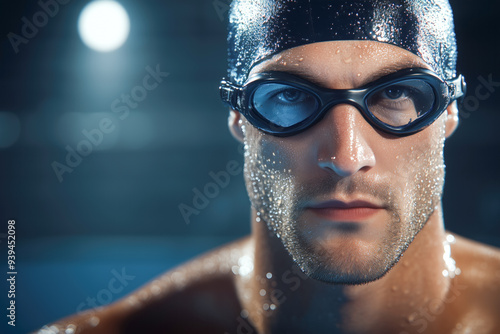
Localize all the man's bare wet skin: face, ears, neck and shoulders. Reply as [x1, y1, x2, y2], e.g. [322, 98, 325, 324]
[40, 41, 500, 334]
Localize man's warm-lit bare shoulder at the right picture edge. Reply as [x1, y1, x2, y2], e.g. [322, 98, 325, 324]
[451, 236, 500, 333]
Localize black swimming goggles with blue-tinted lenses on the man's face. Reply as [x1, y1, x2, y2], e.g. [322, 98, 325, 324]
[219, 68, 466, 136]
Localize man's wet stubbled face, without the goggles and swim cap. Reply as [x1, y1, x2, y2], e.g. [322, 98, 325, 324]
[241, 41, 454, 284]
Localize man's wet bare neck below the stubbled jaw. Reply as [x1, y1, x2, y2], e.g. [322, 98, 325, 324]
[238, 208, 450, 333]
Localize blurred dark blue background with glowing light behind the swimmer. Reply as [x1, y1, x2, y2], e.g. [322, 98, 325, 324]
[0, 0, 500, 333]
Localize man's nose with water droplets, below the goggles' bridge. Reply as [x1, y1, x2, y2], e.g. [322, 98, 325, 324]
[318, 104, 375, 177]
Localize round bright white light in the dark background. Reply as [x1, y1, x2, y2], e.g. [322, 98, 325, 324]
[78, 0, 130, 52]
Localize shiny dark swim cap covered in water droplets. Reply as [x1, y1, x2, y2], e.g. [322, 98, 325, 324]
[228, 0, 457, 85]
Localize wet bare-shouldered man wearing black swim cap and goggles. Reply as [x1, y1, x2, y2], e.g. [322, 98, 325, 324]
[40, 0, 500, 334]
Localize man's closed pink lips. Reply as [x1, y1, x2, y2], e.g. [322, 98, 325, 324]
[307, 200, 384, 222]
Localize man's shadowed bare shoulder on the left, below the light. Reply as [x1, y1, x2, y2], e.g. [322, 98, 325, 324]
[36, 237, 249, 334]
